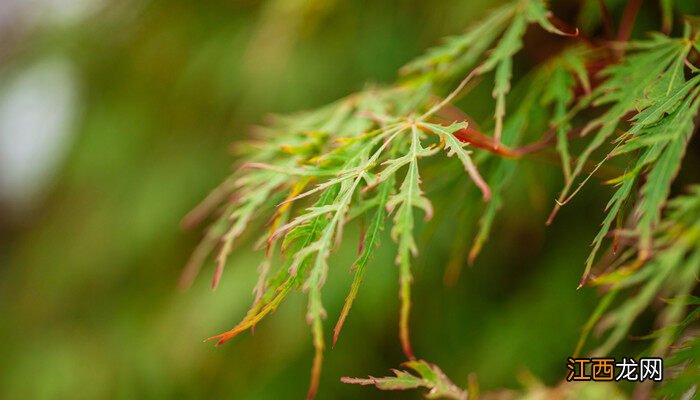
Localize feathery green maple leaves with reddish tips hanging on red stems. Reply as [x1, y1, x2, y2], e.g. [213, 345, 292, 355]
[183, 0, 700, 399]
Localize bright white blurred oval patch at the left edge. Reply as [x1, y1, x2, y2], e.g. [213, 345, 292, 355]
[0, 59, 77, 212]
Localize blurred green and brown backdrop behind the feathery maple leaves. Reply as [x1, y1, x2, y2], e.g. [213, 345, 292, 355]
[0, 0, 668, 399]
